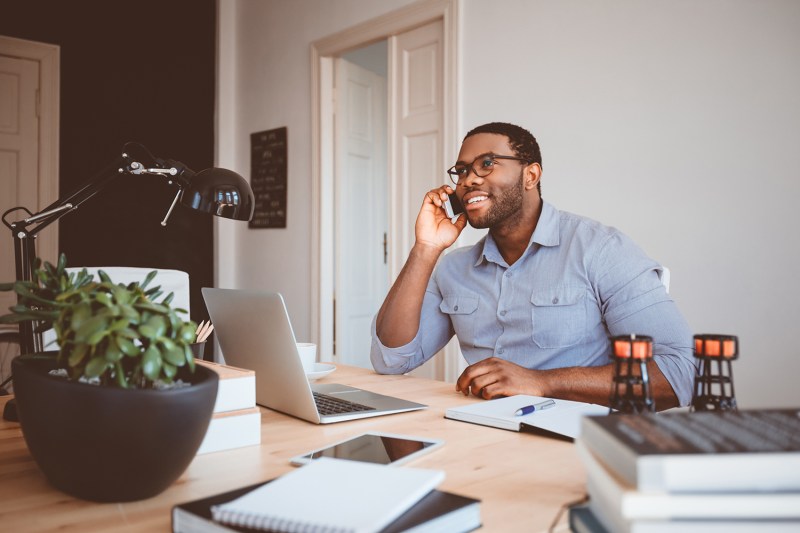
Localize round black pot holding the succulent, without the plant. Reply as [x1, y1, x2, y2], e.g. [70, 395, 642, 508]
[12, 355, 219, 502]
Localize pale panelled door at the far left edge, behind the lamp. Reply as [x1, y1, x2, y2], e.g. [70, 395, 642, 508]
[0, 55, 39, 314]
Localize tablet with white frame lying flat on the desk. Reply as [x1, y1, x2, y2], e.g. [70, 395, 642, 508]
[289, 431, 444, 466]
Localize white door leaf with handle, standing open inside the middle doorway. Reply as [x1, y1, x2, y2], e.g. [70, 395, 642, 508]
[334, 58, 389, 368]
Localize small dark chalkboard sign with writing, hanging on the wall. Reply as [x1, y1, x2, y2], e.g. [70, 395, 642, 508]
[250, 127, 287, 228]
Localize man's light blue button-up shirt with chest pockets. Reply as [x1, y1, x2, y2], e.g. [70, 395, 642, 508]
[371, 202, 695, 405]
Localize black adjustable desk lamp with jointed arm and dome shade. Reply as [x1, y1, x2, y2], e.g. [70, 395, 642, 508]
[2, 143, 255, 353]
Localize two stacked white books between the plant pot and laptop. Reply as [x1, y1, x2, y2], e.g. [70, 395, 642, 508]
[195, 359, 261, 455]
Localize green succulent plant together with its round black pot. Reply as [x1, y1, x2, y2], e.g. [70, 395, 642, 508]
[0, 255, 218, 501]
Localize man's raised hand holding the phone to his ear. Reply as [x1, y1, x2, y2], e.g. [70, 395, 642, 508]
[415, 185, 467, 250]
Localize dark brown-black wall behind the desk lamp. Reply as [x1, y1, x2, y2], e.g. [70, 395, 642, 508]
[0, 0, 216, 350]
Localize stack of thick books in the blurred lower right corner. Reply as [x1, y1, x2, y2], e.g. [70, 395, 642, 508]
[569, 409, 800, 533]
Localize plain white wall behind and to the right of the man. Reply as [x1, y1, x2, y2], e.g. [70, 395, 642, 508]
[462, 0, 800, 407]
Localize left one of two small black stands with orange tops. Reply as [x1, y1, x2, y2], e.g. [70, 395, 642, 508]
[610, 334, 656, 414]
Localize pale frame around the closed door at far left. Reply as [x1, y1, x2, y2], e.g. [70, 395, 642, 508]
[0, 35, 61, 262]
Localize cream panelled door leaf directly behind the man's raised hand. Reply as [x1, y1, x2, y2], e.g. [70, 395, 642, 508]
[389, 20, 446, 379]
